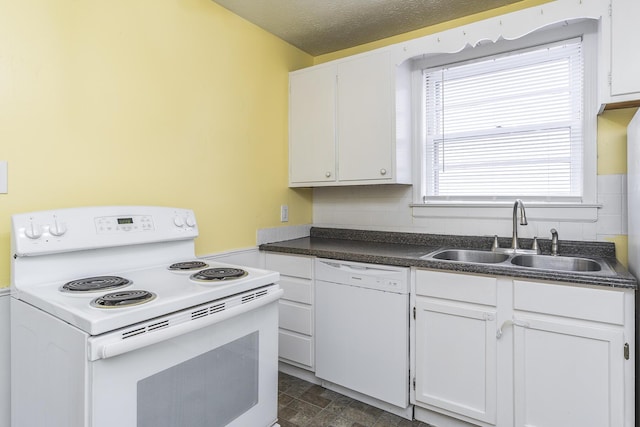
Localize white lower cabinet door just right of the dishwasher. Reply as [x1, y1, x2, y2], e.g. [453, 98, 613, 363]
[415, 297, 497, 424]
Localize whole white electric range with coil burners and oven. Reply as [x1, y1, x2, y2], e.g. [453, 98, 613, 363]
[11, 206, 282, 427]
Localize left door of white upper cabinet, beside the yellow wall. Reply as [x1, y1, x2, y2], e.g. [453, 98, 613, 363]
[289, 64, 336, 186]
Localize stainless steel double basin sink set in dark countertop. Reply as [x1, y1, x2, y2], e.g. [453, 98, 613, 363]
[422, 249, 615, 275]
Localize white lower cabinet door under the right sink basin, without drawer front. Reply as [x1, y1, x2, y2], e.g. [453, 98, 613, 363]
[514, 316, 625, 427]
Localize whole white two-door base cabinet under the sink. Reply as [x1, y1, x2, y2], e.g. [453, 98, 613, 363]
[411, 269, 635, 427]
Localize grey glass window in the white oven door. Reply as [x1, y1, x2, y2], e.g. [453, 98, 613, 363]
[137, 331, 258, 427]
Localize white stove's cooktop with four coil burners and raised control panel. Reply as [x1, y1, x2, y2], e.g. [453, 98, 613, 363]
[11, 206, 279, 335]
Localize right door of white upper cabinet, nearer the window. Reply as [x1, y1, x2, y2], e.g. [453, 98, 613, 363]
[337, 50, 395, 181]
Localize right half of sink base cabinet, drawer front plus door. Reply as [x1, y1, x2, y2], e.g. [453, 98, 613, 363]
[511, 280, 634, 427]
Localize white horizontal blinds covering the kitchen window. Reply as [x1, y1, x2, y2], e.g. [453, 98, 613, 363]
[423, 39, 583, 200]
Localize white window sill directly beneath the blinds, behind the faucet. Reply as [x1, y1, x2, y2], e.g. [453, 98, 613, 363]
[410, 201, 602, 222]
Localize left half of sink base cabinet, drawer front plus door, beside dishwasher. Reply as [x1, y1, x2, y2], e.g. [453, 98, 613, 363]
[414, 270, 497, 424]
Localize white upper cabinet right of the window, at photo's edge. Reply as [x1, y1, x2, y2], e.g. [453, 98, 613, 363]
[601, 0, 640, 104]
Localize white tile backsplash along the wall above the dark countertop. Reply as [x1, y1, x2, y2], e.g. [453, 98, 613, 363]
[313, 174, 627, 241]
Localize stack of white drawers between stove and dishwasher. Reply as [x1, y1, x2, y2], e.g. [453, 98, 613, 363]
[265, 252, 314, 370]
